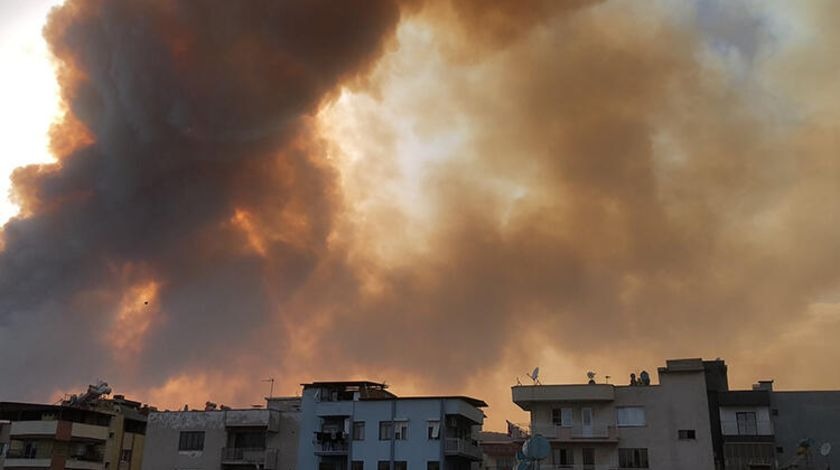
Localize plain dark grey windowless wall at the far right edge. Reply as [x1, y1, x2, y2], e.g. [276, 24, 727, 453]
[770, 392, 840, 468]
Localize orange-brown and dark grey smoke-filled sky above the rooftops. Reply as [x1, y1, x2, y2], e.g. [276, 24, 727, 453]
[0, 0, 840, 428]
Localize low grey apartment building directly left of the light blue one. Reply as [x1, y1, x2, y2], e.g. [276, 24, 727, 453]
[143, 397, 300, 470]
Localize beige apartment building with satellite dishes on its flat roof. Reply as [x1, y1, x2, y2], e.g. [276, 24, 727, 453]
[512, 359, 715, 470]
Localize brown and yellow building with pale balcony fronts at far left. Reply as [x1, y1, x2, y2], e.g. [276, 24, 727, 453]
[0, 400, 145, 470]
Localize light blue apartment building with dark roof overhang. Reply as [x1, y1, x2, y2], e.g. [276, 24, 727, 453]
[298, 381, 487, 470]
